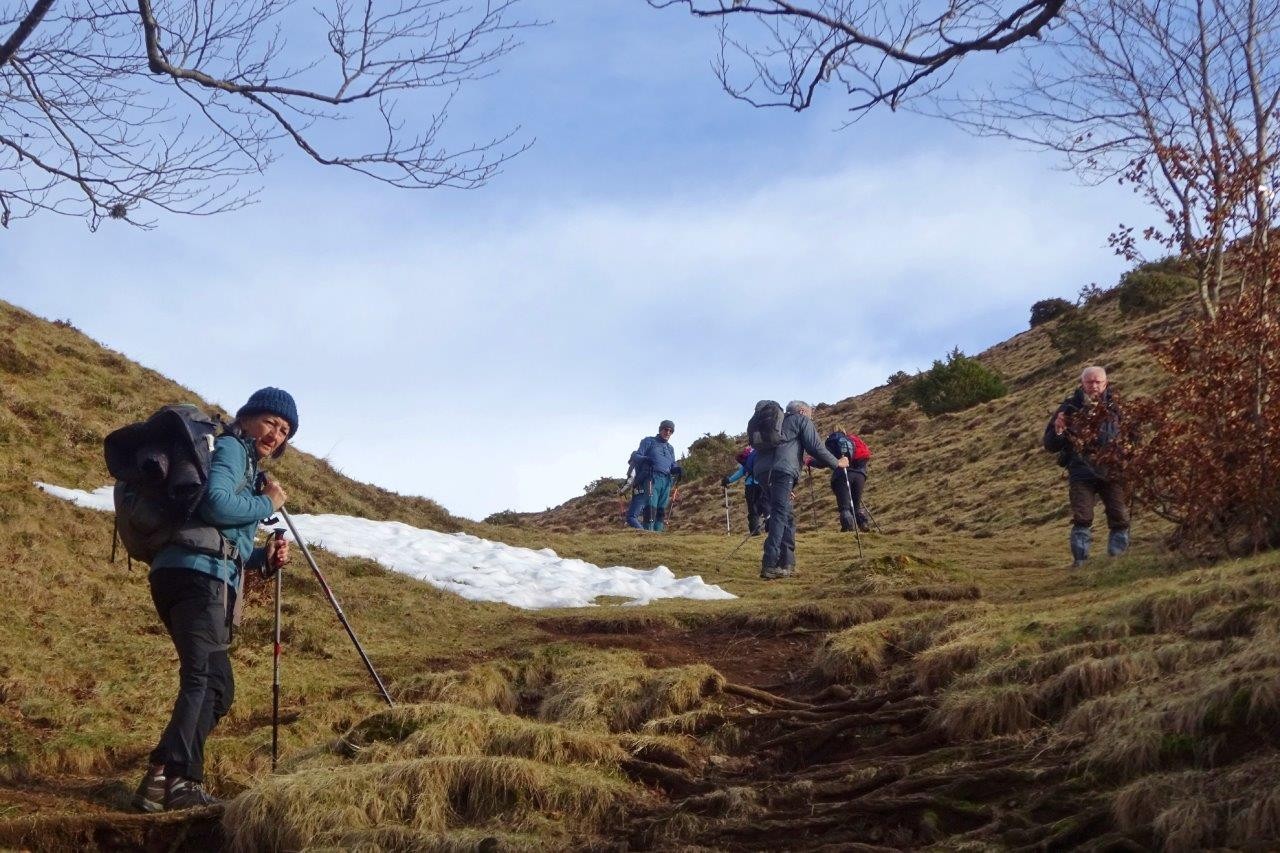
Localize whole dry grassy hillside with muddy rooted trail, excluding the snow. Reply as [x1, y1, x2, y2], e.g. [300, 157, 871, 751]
[0, 289, 1280, 850]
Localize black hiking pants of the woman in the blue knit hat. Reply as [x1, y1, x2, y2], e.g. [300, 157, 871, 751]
[151, 567, 236, 781]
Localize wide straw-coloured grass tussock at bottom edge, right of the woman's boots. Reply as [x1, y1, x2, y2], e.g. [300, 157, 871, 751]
[223, 757, 644, 852]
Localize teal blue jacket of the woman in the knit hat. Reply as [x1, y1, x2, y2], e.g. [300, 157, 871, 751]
[151, 435, 274, 594]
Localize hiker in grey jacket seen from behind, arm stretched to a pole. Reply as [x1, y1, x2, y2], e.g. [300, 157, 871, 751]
[753, 400, 849, 580]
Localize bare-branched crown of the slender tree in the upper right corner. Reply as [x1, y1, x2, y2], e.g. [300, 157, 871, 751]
[941, 0, 1280, 320]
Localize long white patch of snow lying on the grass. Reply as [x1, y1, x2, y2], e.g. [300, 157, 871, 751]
[36, 483, 736, 610]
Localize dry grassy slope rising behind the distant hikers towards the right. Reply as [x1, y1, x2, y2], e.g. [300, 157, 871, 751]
[506, 289, 1177, 537]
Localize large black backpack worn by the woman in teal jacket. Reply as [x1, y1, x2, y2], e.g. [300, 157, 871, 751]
[102, 405, 239, 564]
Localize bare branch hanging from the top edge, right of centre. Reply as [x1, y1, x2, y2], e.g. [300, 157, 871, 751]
[648, 0, 1066, 115]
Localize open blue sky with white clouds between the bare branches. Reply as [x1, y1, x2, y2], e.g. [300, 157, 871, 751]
[0, 0, 1142, 517]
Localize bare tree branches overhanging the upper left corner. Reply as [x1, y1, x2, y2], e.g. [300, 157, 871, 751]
[0, 0, 529, 228]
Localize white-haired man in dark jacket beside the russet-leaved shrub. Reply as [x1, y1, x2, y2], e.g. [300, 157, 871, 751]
[1044, 366, 1129, 567]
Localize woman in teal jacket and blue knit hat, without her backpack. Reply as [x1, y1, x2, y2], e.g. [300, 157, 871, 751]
[133, 388, 298, 812]
